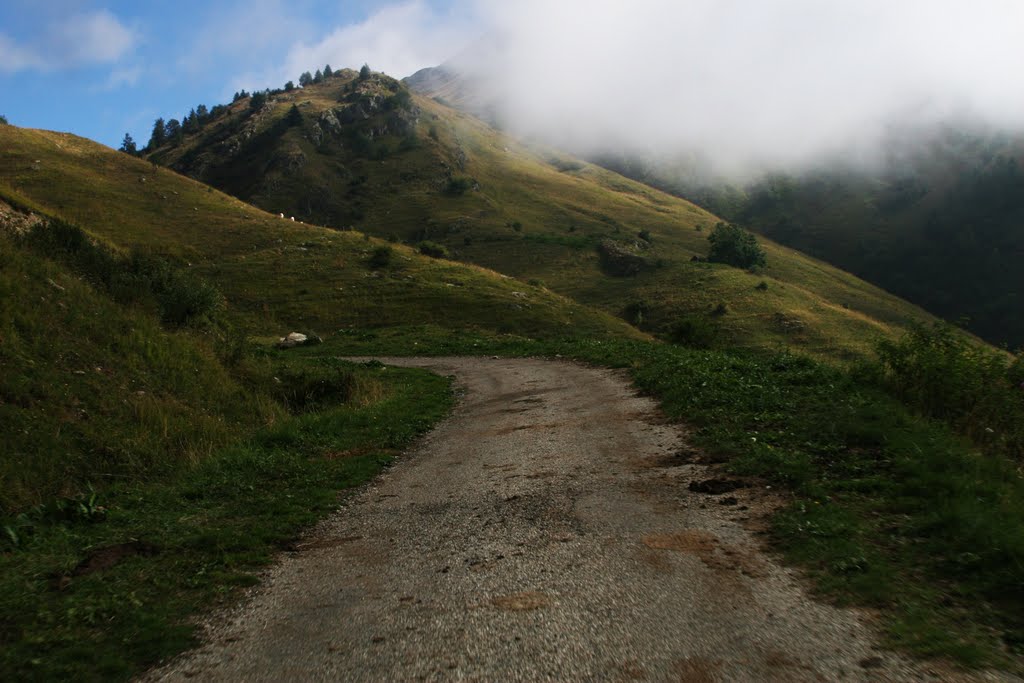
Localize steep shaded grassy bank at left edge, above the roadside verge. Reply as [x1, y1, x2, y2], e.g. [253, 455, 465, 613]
[0, 230, 282, 515]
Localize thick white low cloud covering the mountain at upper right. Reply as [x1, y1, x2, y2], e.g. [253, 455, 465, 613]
[453, 0, 1024, 173]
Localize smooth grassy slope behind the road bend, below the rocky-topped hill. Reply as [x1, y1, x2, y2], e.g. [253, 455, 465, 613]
[0, 126, 638, 344]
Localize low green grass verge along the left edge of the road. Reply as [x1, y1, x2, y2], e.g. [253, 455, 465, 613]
[0, 361, 452, 681]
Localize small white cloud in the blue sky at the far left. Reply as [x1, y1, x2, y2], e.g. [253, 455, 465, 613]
[0, 10, 138, 73]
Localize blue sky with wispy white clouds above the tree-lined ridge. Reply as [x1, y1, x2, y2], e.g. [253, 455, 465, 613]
[0, 0, 473, 147]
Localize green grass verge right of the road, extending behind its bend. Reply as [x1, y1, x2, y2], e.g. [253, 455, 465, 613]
[319, 328, 1024, 671]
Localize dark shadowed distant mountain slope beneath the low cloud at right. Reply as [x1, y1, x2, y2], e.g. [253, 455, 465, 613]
[708, 129, 1024, 348]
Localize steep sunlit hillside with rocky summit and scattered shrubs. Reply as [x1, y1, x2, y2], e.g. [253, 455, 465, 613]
[142, 71, 928, 357]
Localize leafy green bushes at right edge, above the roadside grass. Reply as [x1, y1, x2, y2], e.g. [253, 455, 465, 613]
[871, 324, 1024, 462]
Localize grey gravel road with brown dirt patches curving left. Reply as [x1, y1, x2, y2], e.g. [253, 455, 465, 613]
[146, 358, 1003, 682]
